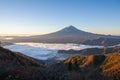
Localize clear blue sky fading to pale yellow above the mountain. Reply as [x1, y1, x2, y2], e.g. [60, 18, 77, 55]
[0, 0, 120, 35]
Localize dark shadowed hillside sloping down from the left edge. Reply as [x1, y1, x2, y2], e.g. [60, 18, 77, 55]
[0, 47, 46, 80]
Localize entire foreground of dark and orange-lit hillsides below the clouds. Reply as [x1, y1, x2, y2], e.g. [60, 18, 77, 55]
[0, 47, 120, 80]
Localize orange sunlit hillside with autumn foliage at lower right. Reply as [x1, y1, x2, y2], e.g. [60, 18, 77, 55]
[50, 53, 120, 80]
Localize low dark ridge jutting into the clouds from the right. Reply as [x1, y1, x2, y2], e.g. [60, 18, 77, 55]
[58, 46, 120, 56]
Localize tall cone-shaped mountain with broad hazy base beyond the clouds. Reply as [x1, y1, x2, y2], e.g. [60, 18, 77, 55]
[8, 25, 120, 43]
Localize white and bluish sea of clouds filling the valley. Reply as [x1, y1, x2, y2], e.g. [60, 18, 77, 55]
[4, 43, 102, 60]
